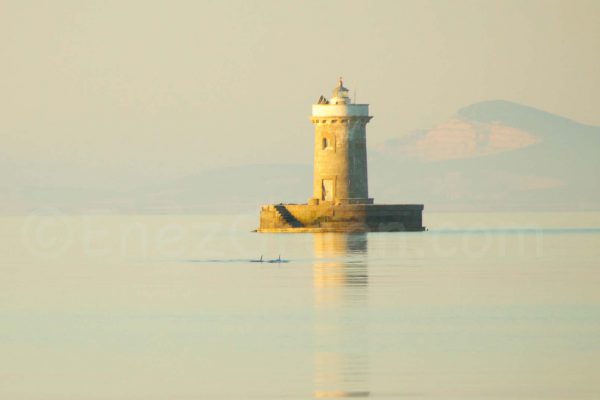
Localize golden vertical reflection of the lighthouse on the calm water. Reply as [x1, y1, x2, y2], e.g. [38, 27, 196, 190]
[313, 233, 370, 398]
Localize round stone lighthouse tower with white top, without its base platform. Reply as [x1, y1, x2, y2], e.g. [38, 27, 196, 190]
[309, 78, 373, 204]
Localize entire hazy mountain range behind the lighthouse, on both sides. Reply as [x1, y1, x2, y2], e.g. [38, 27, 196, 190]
[0, 101, 600, 214]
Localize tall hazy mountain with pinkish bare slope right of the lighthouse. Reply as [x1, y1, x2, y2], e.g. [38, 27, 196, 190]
[370, 101, 600, 210]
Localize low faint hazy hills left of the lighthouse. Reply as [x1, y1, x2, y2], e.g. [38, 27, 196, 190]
[0, 164, 312, 214]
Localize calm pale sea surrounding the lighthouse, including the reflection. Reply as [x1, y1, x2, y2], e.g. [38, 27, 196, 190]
[0, 210, 600, 400]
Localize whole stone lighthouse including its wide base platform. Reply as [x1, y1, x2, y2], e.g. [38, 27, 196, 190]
[257, 78, 425, 232]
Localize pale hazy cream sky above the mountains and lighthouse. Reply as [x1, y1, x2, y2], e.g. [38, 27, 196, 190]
[0, 0, 600, 186]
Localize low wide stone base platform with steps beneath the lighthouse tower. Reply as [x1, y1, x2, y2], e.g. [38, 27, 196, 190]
[257, 204, 425, 233]
